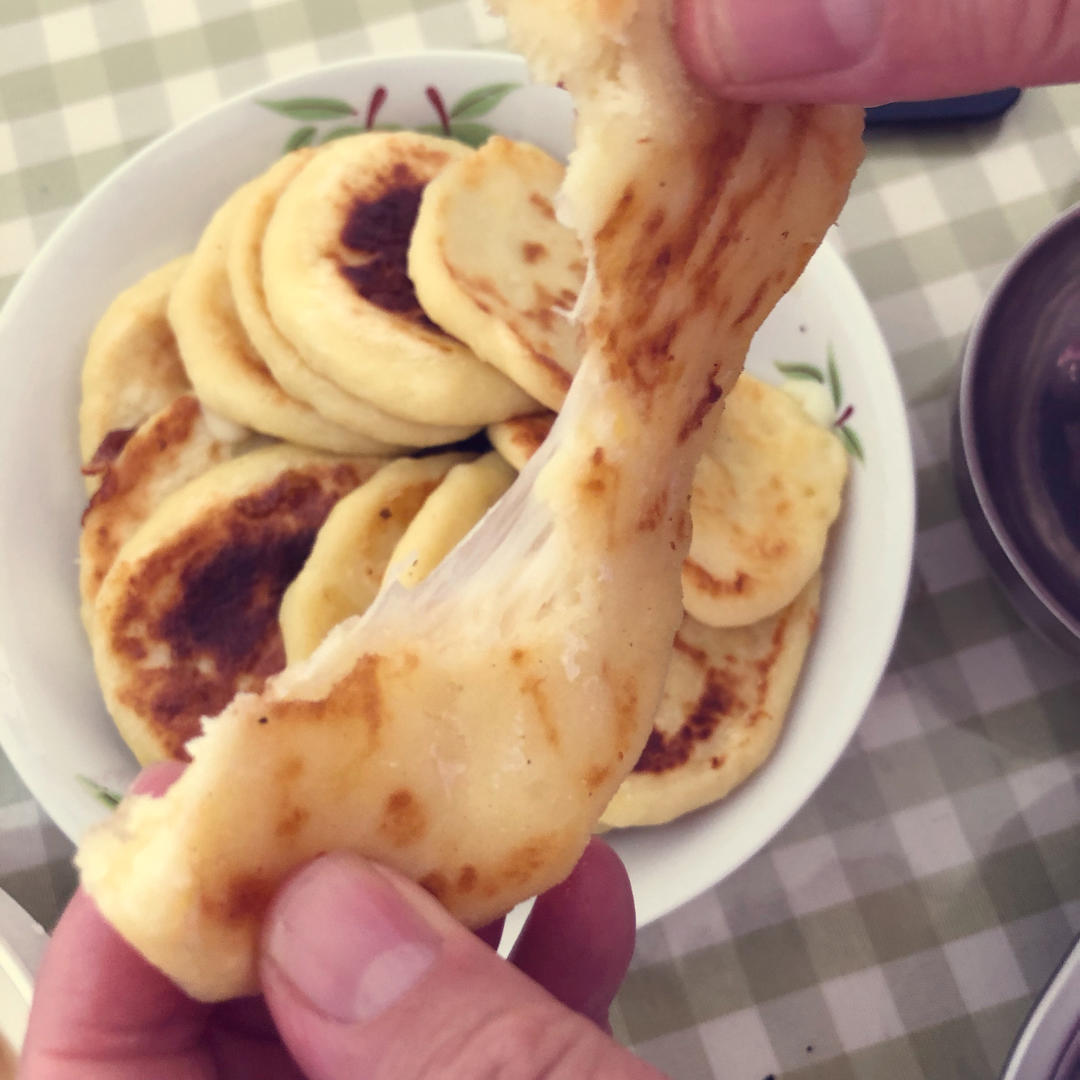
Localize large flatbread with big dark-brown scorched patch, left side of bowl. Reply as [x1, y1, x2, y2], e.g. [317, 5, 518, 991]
[91, 446, 382, 762]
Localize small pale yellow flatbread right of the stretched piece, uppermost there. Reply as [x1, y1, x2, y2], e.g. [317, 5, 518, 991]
[683, 374, 848, 626]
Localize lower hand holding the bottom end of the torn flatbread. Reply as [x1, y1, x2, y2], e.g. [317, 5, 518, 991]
[19, 780, 662, 1080]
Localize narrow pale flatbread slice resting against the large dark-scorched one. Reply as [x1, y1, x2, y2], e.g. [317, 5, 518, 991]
[280, 454, 469, 663]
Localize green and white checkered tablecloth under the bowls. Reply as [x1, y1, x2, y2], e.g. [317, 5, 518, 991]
[0, 0, 1080, 1080]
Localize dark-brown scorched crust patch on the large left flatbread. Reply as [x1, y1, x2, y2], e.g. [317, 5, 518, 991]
[106, 462, 370, 760]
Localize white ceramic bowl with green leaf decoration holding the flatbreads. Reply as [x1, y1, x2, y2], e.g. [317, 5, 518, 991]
[0, 53, 914, 923]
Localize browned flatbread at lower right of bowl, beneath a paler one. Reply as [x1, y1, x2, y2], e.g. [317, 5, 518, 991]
[600, 575, 821, 828]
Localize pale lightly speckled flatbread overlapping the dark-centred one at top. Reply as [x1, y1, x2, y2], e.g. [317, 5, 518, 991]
[408, 135, 585, 408]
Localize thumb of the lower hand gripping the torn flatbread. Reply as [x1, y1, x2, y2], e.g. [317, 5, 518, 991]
[261, 854, 662, 1080]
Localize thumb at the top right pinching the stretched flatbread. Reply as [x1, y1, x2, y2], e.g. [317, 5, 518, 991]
[675, 0, 1080, 105]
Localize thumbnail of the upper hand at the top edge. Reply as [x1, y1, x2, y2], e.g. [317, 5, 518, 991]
[690, 0, 885, 83]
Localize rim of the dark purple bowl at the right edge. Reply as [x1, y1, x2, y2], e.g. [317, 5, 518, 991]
[957, 203, 1080, 638]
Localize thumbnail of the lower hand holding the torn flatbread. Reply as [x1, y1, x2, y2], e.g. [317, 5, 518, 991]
[267, 855, 441, 1024]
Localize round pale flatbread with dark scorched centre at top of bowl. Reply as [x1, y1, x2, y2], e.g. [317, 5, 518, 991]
[262, 132, 536, 427]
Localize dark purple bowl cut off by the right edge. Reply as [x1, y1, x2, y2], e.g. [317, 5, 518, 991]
[953, 206, 1080, 656]
